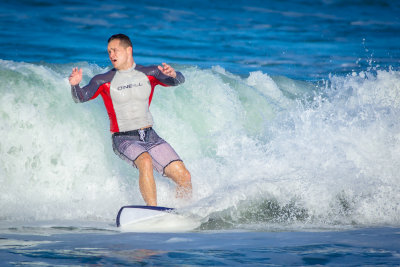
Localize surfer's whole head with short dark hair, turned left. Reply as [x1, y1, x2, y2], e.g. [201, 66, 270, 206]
[107, 33, 134, 70]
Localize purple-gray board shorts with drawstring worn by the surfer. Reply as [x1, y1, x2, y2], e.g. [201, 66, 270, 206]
[112, 127, 182, 175]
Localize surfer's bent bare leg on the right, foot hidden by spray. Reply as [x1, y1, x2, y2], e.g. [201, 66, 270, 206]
[164, 161, 192, 199]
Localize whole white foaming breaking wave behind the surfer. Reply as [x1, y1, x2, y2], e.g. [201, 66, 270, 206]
[0, 61, 400, 229]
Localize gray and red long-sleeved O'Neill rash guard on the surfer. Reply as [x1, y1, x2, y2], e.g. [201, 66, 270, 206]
[71, 64, 185, 133]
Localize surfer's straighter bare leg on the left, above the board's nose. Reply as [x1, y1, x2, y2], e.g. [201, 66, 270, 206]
[135, 152, 157, 206]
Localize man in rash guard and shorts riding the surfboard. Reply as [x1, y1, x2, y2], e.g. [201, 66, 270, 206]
[69, 34, 192, 206]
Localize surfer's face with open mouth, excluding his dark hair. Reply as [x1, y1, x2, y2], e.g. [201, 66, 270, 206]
[107, 39, 132, 70]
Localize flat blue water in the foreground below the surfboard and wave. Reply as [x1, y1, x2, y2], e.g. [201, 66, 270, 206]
[0, 228, 400, 266]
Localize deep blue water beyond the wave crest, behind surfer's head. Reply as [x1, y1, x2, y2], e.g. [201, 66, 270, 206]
[0, 0, 400, 80]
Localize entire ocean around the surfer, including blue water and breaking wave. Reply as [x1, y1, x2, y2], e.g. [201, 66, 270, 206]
[0, 0, 400, 266]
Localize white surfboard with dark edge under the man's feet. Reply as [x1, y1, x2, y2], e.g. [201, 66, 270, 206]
[116, 206, 200, 232]
